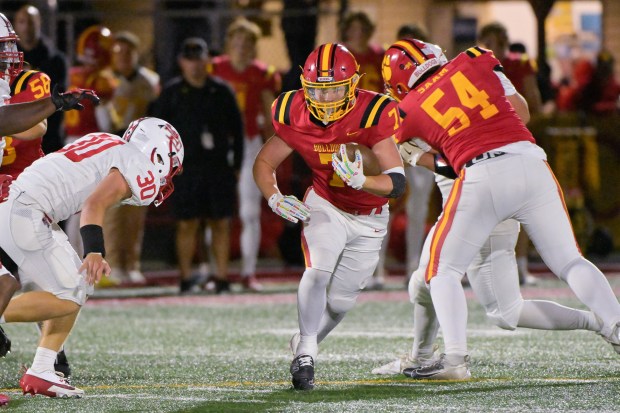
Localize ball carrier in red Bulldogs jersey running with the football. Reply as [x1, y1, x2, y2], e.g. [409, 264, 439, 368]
[254, 43, 405, 390]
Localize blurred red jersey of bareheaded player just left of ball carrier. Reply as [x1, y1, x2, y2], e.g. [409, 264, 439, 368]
[208, 56, 281, 138]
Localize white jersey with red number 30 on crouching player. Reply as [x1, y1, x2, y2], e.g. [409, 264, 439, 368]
[11, 133, 160, 222]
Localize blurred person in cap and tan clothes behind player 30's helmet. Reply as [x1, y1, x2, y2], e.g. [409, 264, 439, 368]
[103, 31, 160, 284]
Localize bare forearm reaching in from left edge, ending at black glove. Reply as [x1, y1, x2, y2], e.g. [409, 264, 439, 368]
[0, 97, 56, 136]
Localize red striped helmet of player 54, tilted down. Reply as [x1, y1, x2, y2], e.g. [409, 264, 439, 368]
[381, 39, 448, 102]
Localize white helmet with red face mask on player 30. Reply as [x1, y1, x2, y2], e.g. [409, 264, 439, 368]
[123, 118, 185, 206]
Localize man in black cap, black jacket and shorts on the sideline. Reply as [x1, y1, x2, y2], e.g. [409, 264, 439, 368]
[149, 37, 243, 294]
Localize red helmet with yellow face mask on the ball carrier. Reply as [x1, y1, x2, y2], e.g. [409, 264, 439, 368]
[301, 43, 360, 123]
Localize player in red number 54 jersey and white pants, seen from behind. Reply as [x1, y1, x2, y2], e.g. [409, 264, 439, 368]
[384, 40, 620, 379]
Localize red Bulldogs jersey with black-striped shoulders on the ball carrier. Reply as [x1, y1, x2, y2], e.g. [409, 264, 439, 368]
[271, 89, 400, 211]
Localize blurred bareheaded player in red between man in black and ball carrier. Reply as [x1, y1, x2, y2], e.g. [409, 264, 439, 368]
[210, 18, 281, 291]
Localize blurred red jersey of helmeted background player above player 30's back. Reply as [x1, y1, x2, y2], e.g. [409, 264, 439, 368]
[65, 66, 117, 137]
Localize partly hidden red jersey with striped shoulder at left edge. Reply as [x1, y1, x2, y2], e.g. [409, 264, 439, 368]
[0, 70, 50, 178]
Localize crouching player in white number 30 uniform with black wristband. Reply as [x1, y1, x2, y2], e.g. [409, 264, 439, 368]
[0, 118, 184, 397]
